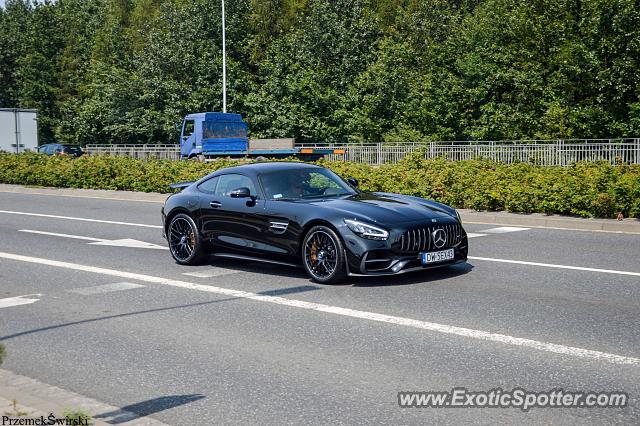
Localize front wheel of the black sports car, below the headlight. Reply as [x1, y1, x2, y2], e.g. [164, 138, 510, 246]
[302, 225, 347, 284]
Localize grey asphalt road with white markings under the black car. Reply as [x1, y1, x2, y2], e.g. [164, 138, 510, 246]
[0, 193, 640, 425]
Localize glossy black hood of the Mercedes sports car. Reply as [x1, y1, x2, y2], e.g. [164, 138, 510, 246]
[311, 192, 455, 224]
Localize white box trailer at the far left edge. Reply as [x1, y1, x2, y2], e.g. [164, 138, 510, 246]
[0, 108, 38, 153]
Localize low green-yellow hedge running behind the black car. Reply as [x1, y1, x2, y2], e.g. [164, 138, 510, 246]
[0, 153, 640, 217]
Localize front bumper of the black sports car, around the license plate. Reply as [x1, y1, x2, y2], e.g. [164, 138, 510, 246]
[345, 221, 469, 275]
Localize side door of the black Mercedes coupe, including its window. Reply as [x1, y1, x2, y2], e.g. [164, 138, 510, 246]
[198, 173, 268, 255]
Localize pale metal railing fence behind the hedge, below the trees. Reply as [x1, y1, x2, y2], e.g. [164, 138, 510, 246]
[86, 138, 640, 166]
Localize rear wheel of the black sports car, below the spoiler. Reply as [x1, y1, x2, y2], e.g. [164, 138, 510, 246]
[167, 213, 206, 265]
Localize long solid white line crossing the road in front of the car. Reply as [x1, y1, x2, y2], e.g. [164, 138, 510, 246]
[0, 252, 640, 366]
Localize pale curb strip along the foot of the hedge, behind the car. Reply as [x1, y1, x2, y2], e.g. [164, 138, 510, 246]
[0, 184, 640, 234]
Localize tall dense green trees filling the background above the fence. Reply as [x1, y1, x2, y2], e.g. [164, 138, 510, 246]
[0, 0, 640, 144]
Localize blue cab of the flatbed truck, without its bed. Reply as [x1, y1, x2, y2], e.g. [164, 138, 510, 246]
[180, 112, 249, 158]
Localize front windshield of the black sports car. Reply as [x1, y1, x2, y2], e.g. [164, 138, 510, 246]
[260, 168, 356, 201]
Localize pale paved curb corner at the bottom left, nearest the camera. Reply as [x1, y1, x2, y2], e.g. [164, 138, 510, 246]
[0, 369, 167, 426]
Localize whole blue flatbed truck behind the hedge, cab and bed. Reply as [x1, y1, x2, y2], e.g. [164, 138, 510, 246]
[180, 112, 344, 161]
